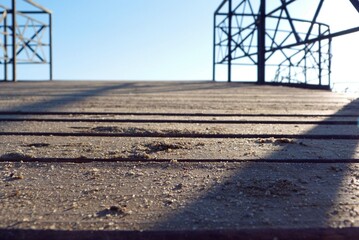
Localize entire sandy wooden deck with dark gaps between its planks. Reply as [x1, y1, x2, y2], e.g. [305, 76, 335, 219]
[0, 81, 359, 239]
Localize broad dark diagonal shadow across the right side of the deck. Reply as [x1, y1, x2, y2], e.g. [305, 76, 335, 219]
[153, 100, 359, 235]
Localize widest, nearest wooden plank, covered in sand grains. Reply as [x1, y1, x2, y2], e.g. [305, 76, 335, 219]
[0, 162, 359, 231]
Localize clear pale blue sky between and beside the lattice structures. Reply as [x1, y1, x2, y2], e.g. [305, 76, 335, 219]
[5, 0, 359, 90]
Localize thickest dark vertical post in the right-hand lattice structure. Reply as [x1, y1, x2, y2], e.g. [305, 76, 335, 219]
[257, 0, 266, 84]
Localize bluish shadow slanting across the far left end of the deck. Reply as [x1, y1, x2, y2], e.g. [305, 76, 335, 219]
[0, 81, 253, 113]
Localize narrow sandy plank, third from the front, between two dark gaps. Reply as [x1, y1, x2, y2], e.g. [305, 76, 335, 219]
[0, 119, 359, 138]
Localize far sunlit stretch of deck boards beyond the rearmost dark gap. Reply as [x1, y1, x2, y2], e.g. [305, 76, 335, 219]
[1, 82, 352, 114]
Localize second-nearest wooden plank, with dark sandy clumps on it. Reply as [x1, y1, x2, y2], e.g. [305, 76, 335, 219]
[0, 136, 359, 162]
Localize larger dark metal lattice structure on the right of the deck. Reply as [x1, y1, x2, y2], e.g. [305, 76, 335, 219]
[213, 0, 359, 88]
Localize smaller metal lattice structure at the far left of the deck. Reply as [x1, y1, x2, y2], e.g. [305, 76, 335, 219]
[0, 0, 53, 81]
